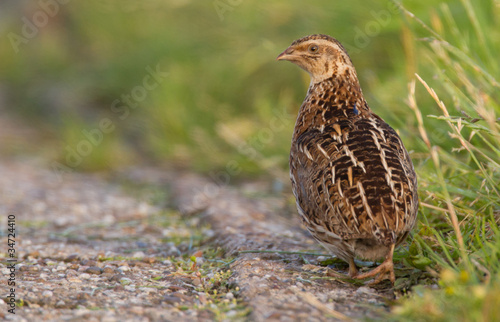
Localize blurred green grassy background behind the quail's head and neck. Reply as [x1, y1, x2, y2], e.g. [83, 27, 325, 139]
[0, 0, 484, 176]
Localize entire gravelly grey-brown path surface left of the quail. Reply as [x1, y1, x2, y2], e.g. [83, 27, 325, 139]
[0, 156, 392, 321]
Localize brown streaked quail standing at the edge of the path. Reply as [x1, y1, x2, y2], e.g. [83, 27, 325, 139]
[277, 35, 418, 284]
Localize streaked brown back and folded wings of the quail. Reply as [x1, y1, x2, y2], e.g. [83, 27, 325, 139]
[290, 116, 417, 243]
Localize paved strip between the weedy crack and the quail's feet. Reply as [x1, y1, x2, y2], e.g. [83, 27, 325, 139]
[175, 177, 393, 321]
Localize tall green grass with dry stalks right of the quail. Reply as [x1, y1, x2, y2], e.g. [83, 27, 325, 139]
[392, 0, 500, 321]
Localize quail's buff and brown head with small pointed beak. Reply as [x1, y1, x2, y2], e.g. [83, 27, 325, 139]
[276, 35, 356, 83]
